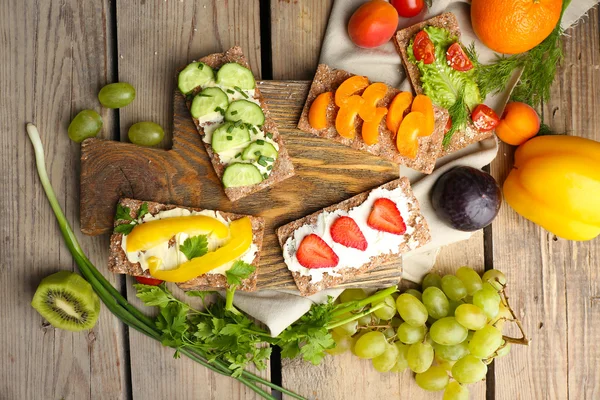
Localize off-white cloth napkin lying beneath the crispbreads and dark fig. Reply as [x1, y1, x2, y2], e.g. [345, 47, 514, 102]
[234, 0, 596, 336]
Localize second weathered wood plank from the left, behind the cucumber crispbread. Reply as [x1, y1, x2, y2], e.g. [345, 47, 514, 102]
[117, 0, 268, 399]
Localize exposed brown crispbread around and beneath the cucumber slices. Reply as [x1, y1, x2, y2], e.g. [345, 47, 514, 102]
[181, 46, 294, 201]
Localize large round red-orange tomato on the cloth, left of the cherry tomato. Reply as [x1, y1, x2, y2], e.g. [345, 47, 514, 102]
[348, 0, 398, 49]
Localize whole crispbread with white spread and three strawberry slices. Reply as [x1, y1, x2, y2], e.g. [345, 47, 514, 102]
[276, 178, 431, 296]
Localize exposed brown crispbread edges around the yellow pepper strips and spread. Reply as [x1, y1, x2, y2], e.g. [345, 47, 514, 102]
[108, 198, 265, 292]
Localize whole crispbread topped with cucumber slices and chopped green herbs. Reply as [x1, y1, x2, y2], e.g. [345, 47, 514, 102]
[177, 46, 294, 201]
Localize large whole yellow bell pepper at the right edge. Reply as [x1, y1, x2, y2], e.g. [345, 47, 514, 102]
[504, 135, 600, 240]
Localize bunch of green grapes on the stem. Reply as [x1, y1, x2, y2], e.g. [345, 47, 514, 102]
[327, 267, 529, 400]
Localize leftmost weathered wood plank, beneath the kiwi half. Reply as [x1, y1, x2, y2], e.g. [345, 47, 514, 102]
[0, 0, 128, 399]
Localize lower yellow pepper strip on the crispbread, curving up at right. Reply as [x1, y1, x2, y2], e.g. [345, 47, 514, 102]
[148, 217, 253, 282]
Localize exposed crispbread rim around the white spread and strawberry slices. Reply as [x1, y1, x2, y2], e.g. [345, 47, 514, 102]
[276, 178, 431, 296]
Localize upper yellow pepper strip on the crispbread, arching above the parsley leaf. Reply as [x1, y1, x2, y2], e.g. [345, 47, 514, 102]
[127, 215, 229, 253]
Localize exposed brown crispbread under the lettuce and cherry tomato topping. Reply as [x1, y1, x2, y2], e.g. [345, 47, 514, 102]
[394, 13, 494, 156]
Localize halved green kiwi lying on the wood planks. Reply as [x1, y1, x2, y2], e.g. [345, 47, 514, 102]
[31, 271, 100, 331]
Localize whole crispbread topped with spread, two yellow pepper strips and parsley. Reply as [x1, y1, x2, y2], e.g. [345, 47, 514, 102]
[108, 198, 265, 291]
